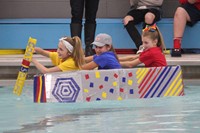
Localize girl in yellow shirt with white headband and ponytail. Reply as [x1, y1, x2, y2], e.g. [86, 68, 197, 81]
[32, 36, 84, 74]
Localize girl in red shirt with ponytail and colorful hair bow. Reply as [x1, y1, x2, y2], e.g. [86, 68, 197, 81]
[119, 24, 167, 68]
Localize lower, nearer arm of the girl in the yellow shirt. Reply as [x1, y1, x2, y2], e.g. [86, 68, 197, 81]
[32, 58, 61, 74]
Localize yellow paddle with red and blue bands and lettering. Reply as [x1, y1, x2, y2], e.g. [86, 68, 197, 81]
[13, 37, 37, 96]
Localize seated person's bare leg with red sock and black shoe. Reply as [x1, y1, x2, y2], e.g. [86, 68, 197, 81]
[171, 0, 200, 57]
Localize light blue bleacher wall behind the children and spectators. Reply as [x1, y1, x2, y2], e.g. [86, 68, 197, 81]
[0, 18, 200, 49]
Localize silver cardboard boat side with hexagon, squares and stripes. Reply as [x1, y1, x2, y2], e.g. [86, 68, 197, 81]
[34, 66, 184, 103]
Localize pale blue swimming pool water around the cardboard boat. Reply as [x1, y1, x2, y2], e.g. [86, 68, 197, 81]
[0, 86, 200, 133]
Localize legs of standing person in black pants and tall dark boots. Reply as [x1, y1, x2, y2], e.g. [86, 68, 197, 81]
[70, 0, 99, 56]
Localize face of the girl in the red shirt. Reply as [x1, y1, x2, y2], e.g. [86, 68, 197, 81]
[142, 36, 158, 50]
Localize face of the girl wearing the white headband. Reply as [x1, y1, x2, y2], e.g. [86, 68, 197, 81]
[57, 42, 70, 59]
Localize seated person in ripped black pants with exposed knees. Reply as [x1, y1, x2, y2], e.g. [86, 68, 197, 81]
[123, 0, 163, 53]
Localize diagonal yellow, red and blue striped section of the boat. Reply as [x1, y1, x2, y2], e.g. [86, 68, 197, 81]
[136, 66, 184, 98]
